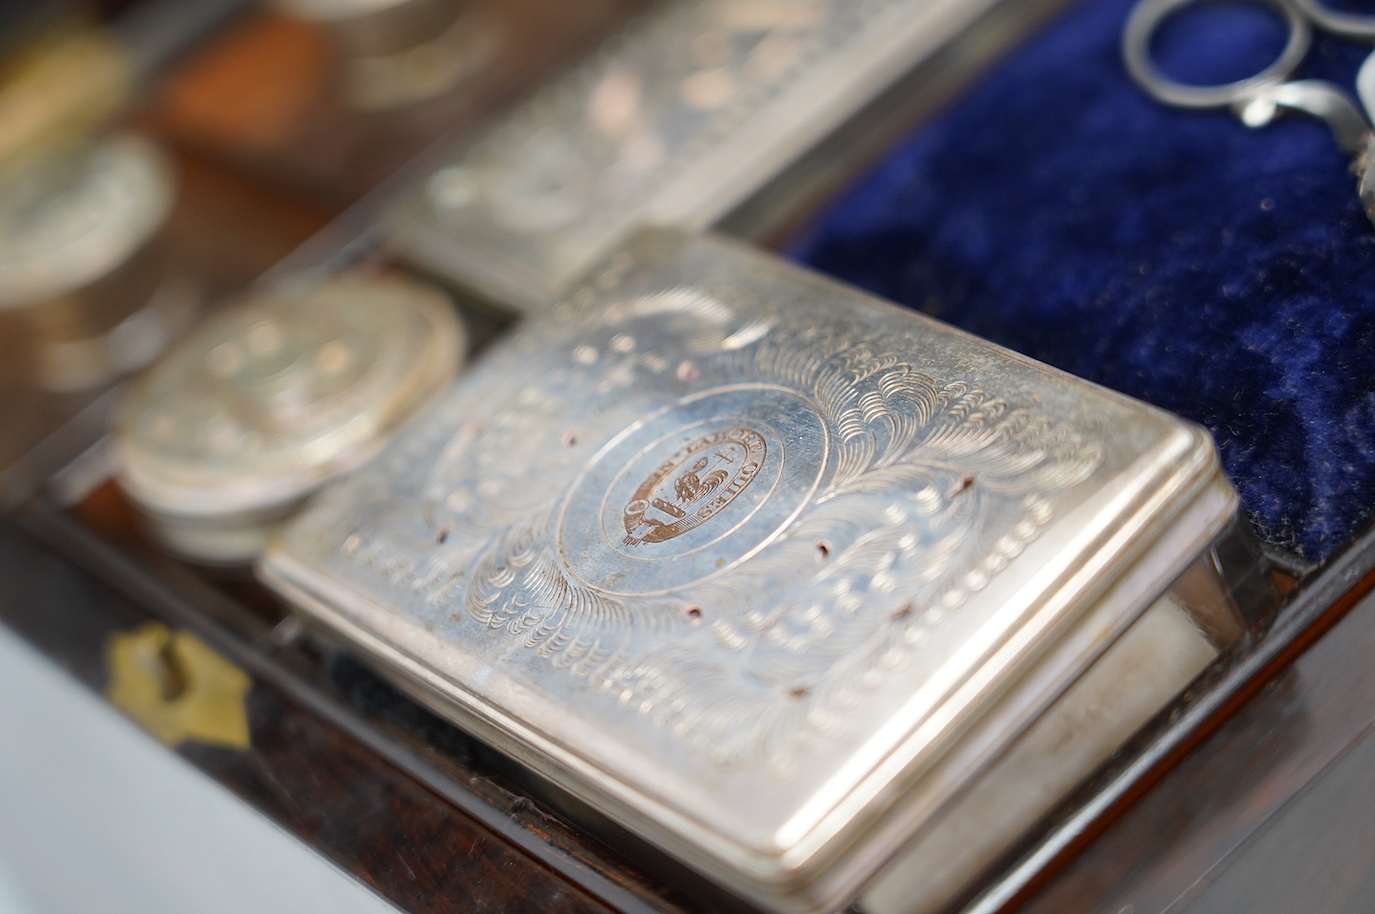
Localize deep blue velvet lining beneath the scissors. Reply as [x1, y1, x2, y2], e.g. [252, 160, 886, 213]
[792, 0, 1375, 559]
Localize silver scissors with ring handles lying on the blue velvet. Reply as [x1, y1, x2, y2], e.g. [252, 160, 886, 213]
[1122, 0, 1375, 223]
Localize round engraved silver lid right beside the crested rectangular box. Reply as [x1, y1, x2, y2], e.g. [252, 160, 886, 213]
[113, 275, 463, 518]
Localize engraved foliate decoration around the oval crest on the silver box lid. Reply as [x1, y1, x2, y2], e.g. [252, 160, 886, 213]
[327, 281, 1101, 774]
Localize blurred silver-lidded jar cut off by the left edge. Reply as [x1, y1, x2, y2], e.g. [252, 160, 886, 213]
[0, 136, 198, 392]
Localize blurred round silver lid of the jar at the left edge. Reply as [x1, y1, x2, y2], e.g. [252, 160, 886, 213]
[0, 136, 175, 308]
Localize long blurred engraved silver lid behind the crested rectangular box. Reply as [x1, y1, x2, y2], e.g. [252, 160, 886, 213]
[386, 0, 1028, 311]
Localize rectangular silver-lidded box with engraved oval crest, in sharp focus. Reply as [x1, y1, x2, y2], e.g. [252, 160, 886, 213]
[260, 230, 1246, 911]
